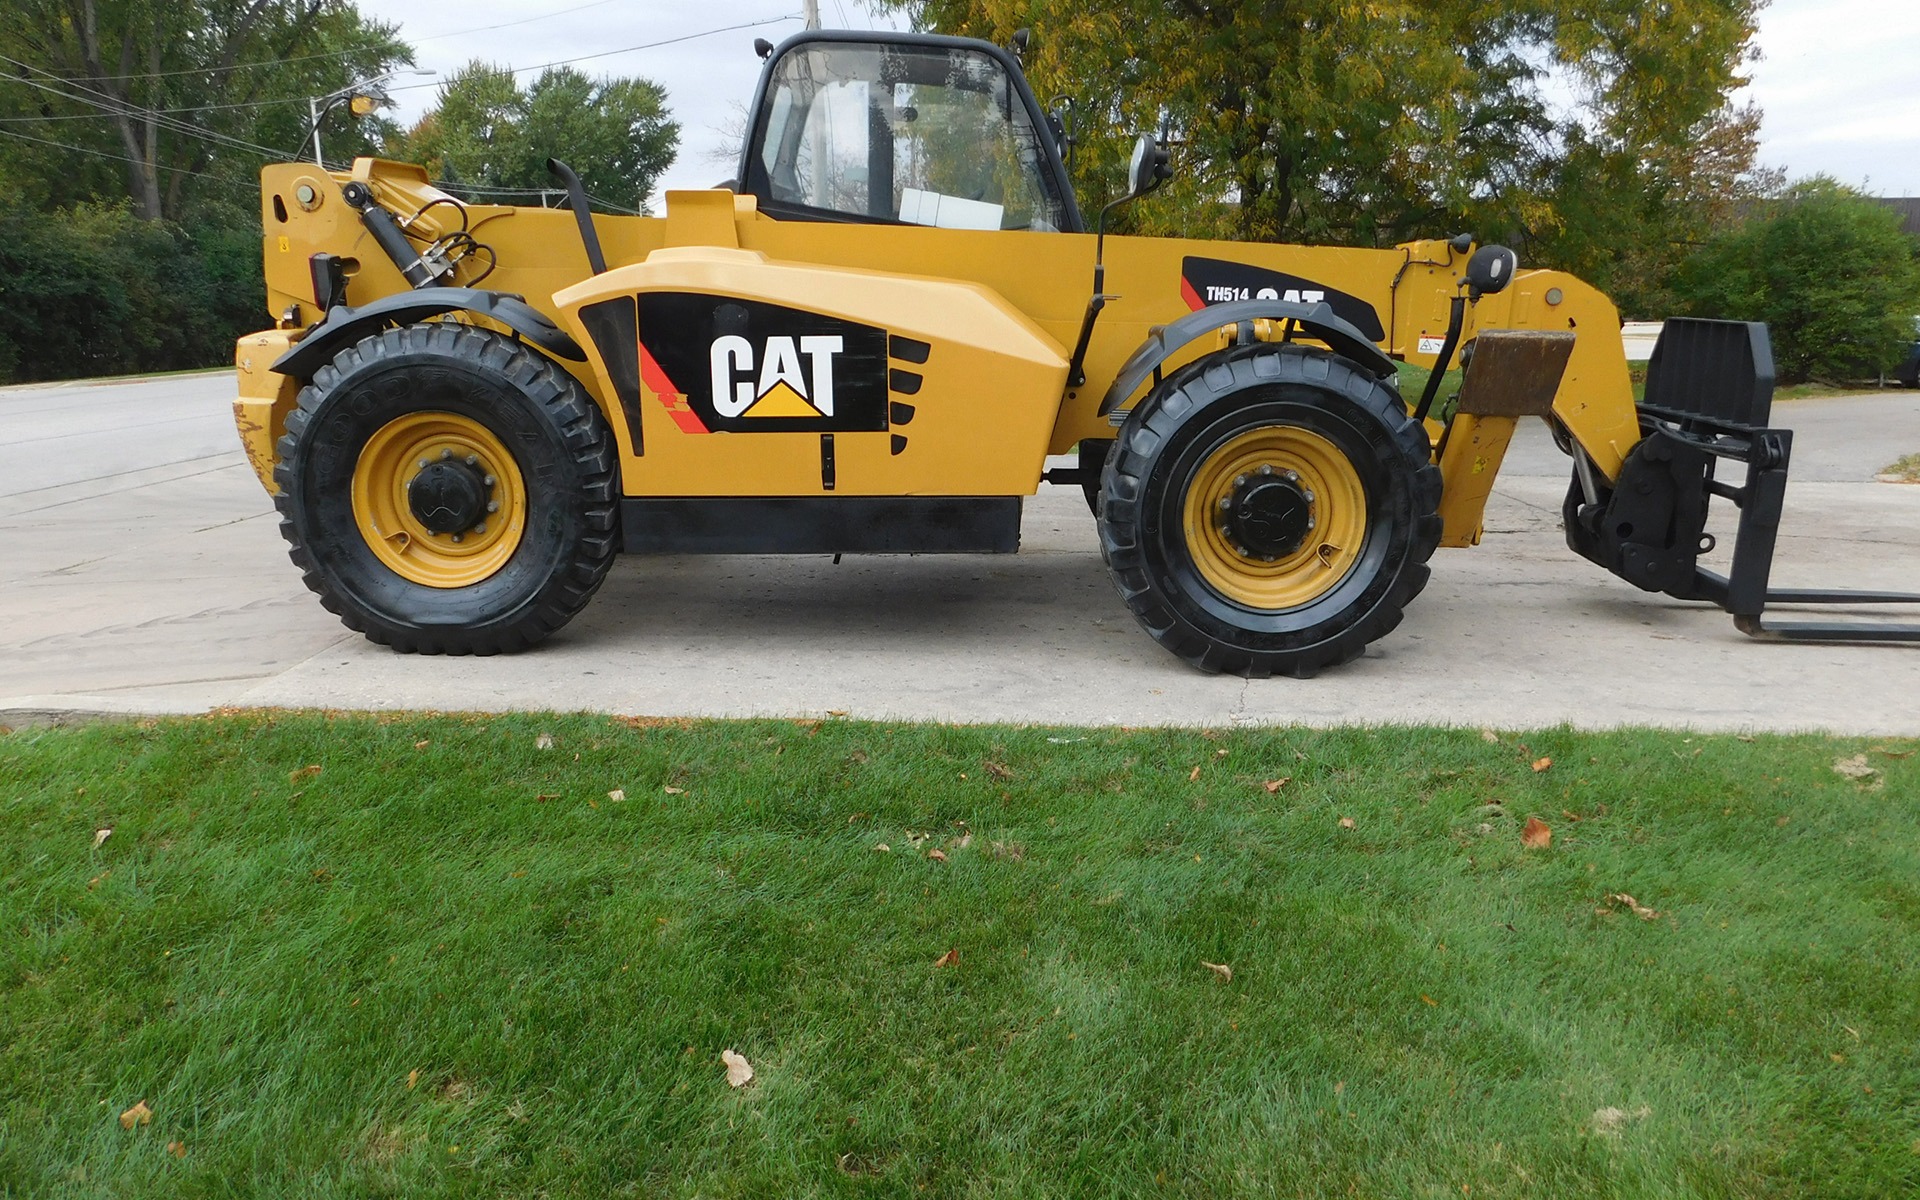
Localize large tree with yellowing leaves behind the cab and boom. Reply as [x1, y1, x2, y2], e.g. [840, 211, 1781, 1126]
[883, 0, 1764, 299]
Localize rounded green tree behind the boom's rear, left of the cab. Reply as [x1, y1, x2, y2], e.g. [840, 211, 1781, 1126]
[388, 61, 680, 211]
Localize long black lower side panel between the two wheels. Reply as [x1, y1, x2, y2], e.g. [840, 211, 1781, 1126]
[620, 495, 1020, 555]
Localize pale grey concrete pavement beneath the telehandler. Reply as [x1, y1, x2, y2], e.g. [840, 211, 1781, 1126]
[0, 372, 1920, 733]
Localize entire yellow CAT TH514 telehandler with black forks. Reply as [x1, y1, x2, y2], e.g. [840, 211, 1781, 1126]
[234, 31, 1920, 676]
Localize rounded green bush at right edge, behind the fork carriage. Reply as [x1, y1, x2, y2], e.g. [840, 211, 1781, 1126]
[1674, 177, 1920, 382]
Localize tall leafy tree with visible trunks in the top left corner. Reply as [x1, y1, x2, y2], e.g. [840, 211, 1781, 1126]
[0, 0, 413, 219]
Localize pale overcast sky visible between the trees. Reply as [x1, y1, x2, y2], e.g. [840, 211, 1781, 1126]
[382, 0, 1920, 208]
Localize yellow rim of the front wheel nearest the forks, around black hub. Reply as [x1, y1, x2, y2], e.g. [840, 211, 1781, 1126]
[1183, 424, 1367, 611]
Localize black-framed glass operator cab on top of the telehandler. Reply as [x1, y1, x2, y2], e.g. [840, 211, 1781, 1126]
[739, 31, 1083, 232]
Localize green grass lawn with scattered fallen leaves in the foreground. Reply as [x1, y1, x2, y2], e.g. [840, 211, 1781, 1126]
[0, 712, 1920, 1200]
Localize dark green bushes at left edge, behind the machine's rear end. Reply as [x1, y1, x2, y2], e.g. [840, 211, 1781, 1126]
[0, 205, 267, 382]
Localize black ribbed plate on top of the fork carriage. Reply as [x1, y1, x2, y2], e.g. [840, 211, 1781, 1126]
[1642, 317, 1774, 426]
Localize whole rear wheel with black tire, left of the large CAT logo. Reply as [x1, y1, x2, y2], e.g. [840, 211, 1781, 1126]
[275, 323, 618, 655]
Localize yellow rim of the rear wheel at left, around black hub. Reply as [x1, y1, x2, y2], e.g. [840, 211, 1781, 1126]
[353, 413, 526, 588]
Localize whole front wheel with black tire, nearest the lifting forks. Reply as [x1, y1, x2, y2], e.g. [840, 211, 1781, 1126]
[1100, 344, 1440, 678]
